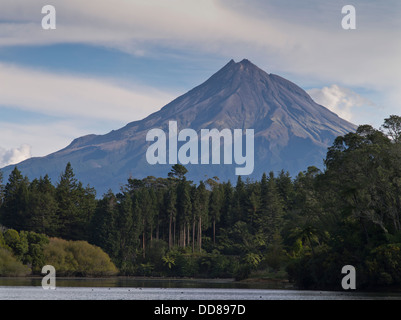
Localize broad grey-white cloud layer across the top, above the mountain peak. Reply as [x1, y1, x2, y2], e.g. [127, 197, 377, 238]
[0, 0, 401, 90]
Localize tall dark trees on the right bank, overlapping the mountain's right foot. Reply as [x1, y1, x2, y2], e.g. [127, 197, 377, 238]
[287, 120, 401, 288]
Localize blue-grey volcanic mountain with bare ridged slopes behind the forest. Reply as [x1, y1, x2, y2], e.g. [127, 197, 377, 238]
[3, 59, 356, 193]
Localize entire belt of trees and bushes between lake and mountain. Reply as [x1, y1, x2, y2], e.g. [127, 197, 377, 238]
[0, 115, 401, 289]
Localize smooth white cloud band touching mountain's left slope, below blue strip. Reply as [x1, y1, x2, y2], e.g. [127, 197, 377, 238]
[0, 63, 172, 123]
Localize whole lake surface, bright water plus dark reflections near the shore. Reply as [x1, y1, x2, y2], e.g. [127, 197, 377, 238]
[0, 278, 401, 300]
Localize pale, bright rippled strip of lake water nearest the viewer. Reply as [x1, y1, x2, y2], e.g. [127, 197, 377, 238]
[0, 286, 401, 300]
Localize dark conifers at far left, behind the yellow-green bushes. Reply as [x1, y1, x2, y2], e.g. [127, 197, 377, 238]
[0, 163, 97, 240]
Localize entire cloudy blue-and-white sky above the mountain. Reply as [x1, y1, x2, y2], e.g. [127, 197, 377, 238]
[0, 0, 401, 167]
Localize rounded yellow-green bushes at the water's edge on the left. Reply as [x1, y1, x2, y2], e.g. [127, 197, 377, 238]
[0, 229, 118, 276]
